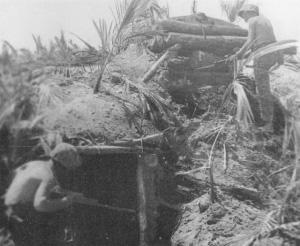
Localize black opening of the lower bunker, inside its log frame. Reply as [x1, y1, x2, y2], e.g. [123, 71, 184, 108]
[61, 154, 139, 246]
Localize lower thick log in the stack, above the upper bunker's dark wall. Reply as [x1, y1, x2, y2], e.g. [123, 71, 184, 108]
[166, 33, 247, 56]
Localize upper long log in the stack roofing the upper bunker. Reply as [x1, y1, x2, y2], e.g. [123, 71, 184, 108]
[152, 19, 248, 37]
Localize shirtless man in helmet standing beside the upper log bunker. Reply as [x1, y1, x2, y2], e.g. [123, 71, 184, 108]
[229, 4, 279, 132]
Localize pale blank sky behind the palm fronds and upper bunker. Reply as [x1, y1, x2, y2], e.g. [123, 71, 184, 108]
[0, 0, 300, 49]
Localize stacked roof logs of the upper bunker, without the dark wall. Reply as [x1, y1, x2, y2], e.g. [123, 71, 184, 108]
[149, 13, 248, 56]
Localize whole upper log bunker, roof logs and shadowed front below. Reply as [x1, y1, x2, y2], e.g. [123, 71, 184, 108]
[142, 13, 248, 115]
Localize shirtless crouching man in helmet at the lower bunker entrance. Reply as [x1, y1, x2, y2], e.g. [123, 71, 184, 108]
[4, 143, 81, 246]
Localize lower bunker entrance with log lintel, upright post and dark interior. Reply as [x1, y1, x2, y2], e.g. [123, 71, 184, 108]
[56, 143, 160, 246]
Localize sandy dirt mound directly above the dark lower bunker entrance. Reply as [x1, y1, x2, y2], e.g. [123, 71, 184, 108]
[41, 46, 161, 143]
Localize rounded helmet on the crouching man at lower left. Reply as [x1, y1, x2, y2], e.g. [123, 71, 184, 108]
[50, 143, 81, 169]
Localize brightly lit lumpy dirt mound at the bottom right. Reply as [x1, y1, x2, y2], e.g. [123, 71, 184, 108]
[171, 198, 283, 246]
